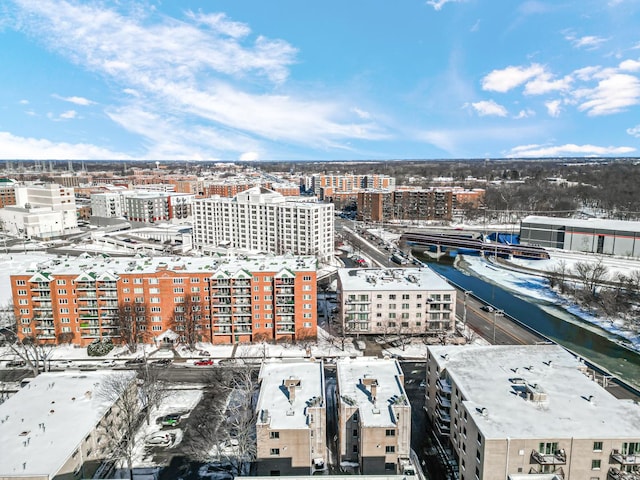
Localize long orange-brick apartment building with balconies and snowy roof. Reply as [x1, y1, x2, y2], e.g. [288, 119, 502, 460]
[11, 256, 317, 345]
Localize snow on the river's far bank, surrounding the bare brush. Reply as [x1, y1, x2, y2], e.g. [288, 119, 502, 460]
[464, 252, 640, 351]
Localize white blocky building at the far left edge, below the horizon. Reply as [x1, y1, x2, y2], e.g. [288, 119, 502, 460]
[0, 184, 78, 238]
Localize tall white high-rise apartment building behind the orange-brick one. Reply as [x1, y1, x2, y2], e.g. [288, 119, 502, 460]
[193, 187, 334, 261]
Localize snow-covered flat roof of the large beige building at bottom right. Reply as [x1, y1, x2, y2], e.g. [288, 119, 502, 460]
[428, 345, 640, 441]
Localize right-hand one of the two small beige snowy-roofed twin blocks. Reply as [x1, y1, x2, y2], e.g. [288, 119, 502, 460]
[336, 357, 411, 475]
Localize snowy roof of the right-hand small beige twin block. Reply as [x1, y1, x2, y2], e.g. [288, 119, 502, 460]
[336, 357, 409, 427]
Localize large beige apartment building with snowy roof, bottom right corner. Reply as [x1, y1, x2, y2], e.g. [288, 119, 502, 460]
[425, 345, 640, 480]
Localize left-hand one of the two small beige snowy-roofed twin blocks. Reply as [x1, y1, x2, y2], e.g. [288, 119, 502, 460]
[256, 360, 327, 476]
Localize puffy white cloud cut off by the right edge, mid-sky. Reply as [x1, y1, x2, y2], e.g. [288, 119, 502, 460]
[575, 73, 640, 116]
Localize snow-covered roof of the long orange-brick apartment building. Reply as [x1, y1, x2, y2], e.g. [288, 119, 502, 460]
[15, 251, 316, 276]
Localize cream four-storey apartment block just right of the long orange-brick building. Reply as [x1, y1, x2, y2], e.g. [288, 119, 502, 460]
[338, 268, 456, 335]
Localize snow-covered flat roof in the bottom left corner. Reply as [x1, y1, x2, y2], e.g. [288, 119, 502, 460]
[0, 370, 134, 477]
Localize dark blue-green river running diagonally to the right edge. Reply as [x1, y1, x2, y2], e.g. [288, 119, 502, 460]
[416, 255, 640, 387]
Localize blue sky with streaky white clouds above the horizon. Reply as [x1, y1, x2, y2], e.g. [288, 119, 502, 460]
[0, 0, 640, 160]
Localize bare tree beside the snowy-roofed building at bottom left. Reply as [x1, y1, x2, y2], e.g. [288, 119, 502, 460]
[97, 372, 142, 480]
